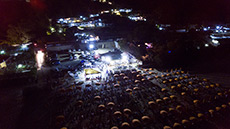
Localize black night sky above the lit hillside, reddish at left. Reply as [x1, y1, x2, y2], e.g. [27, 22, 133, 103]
[0, 0, 230, 35]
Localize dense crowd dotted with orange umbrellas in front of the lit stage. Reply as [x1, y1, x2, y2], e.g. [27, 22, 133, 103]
[49, 68, 230, 129]
